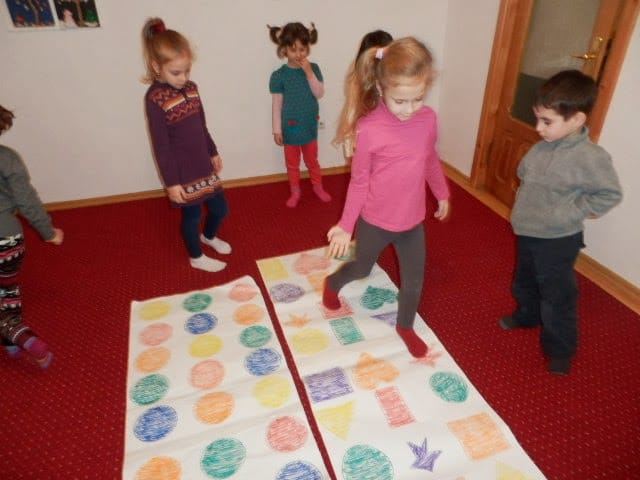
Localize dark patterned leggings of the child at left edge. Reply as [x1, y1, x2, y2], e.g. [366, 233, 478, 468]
[0, 234, 28, 345]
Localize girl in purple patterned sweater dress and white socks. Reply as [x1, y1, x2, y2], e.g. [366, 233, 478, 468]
[142, 18, 231, 272]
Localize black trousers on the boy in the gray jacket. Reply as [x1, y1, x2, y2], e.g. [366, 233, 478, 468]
[512, 232, 584, 358]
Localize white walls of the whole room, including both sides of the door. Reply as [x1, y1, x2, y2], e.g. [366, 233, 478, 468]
[0, 0, 640, 287]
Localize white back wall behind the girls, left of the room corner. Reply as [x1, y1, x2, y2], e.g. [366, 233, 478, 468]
[0, 0, 447, 202]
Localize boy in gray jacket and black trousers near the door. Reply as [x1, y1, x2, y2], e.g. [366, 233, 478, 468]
[500, 70, 622, 375]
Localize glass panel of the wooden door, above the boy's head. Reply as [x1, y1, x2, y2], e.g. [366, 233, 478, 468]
[511, 0, 601, 126]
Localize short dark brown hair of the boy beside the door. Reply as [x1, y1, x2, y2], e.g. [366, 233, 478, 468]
[533, 70, 598, 120]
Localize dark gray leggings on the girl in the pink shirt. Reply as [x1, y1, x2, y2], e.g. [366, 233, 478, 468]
[327, 218, 426, 328]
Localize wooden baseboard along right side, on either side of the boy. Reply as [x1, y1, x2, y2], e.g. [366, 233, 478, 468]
[444, 163, 640, 314]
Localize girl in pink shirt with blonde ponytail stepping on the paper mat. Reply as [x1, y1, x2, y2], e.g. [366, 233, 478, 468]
[322, 37, 449, 358]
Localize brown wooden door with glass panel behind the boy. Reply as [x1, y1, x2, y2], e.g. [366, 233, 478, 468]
[471, 0, 640, 207]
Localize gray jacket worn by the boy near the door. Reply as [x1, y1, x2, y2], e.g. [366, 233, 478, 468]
[511, 127, 622, 238]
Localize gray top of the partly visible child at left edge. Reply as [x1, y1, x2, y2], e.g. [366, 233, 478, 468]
[0, 145, 55, 240]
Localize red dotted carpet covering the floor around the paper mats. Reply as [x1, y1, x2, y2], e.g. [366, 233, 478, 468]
[0, 175, 640, 480]
